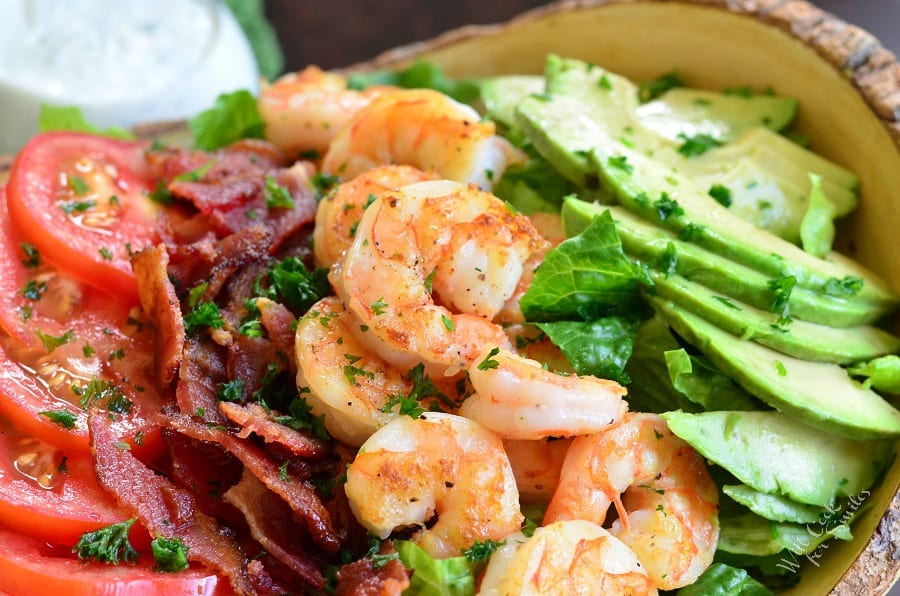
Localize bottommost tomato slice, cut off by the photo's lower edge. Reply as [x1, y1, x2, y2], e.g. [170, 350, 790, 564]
[0, 527, 233, 596]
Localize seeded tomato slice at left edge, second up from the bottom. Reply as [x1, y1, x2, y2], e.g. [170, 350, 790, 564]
[0, 419, 150, 547]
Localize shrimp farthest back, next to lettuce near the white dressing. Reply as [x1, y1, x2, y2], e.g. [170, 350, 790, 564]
[257, 66, 386, 155]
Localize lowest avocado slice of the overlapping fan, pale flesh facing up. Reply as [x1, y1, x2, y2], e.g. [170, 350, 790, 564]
[649, 297, 900, 440]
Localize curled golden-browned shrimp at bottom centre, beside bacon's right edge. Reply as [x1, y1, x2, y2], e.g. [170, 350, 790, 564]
[345, 413, 524, 558]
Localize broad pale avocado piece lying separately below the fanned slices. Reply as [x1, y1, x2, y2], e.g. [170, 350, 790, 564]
[662, 411, 894, 507]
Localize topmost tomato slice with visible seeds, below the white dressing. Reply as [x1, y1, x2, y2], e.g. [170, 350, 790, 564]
[7, 132, 158, 304]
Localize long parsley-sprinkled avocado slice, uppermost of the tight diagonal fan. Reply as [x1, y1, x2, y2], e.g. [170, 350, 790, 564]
[590, 146, 897, 310]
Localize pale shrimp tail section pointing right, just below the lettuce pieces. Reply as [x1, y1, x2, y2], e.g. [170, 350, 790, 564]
[459, 348, 628, 439]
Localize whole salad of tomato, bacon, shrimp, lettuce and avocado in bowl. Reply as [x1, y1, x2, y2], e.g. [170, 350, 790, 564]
[0, 49, 900, 594]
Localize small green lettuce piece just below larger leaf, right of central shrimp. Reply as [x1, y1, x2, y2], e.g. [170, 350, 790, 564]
[537, 317, 638, 385]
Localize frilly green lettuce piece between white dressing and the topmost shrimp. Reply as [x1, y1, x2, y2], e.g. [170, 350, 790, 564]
[188, 89, 265, 151]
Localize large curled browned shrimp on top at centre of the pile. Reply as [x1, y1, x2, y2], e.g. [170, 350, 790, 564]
[331, 180, 544, 374]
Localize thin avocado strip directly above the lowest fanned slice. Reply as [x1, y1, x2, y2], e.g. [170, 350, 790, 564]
[648, 269, 900, 364]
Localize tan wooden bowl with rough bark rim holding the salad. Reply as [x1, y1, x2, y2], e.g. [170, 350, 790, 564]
[350, 0, 900, 596]
